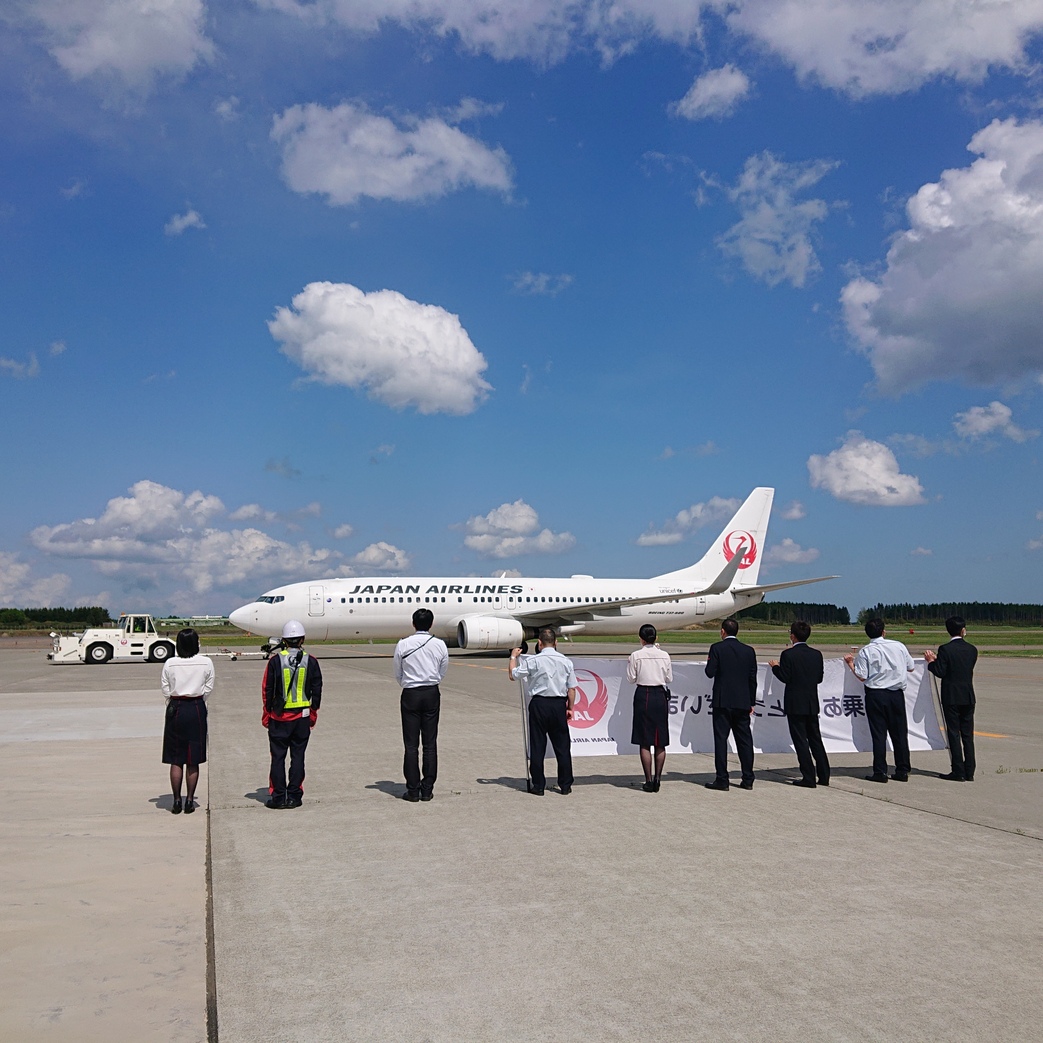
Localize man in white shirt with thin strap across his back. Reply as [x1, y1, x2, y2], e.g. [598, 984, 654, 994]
[394, 608, 450, 804]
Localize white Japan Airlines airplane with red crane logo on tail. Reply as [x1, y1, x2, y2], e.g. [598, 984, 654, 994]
[228, 487, 838, 650]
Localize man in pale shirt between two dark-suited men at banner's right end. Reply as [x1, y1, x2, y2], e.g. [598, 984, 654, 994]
[844, 620, 916, 782]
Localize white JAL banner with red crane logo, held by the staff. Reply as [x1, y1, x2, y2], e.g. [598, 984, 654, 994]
[521, 656, 945, 757]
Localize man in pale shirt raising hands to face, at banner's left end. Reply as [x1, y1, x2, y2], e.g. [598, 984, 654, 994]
[507, 627, 576, 797]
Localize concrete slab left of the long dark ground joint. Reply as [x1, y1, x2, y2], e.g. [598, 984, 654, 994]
[0, 684, 207, 1043]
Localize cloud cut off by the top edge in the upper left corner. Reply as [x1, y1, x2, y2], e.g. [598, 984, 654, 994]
[32, 0, 214, 90]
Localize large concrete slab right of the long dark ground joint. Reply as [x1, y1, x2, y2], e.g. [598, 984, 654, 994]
[212, 658, 1043, 1043]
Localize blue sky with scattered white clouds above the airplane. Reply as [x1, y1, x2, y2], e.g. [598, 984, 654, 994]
[0, 0, 1043, 612]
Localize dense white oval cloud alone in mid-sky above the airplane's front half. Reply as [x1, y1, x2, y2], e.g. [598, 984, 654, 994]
[268, 283, 491, 415]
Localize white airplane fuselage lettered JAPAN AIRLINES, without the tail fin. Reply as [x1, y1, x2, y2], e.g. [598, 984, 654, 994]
[231, 576, 762, 644]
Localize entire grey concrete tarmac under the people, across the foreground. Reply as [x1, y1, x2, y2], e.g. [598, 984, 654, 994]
[0, 645, 1043, 1043]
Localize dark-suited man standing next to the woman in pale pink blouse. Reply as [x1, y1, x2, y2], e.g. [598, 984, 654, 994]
[705, 620, 757, 790]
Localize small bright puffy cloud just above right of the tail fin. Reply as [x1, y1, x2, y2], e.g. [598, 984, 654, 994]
[807, 431, 924, 507]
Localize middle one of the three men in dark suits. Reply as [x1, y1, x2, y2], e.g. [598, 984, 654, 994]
[768, 620, 829, 790]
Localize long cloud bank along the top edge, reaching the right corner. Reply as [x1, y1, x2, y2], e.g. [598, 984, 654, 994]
[258, 0, 1043, 97]
